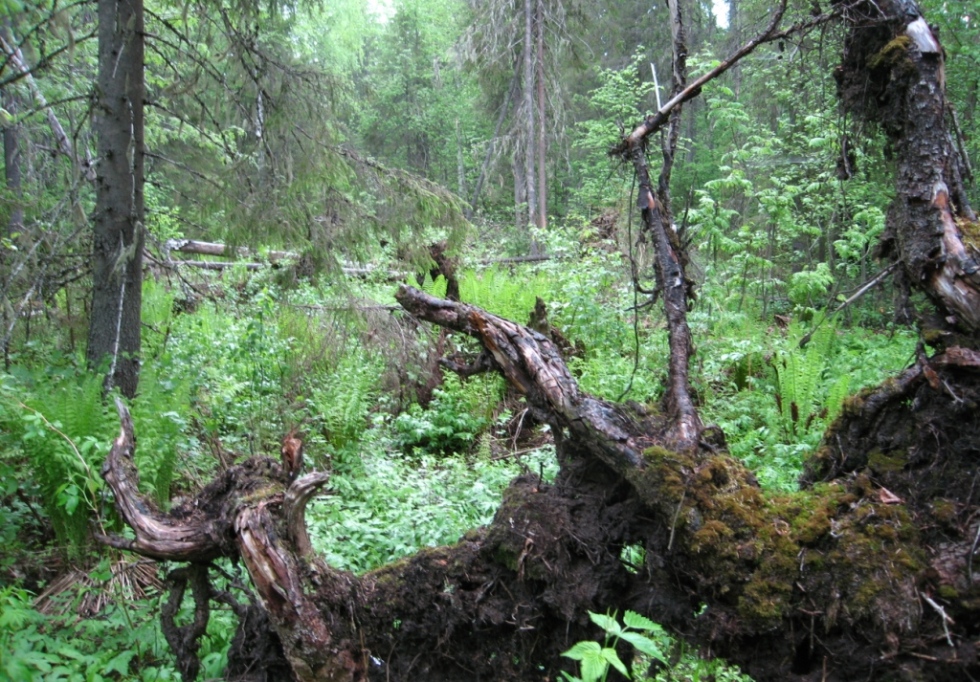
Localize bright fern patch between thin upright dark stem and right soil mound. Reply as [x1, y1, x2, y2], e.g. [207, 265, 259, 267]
[691, 294, 915, 490]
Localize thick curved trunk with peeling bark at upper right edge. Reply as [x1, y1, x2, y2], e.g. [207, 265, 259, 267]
[836, 0, 980, 336]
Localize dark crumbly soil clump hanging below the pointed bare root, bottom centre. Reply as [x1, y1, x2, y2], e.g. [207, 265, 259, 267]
[344, 452, 652, 682]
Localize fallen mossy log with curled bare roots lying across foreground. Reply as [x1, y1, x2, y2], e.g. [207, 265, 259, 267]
[99, 288, 980, 682]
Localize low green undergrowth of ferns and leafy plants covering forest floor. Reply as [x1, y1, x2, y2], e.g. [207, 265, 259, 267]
[0, 224, 915, 681]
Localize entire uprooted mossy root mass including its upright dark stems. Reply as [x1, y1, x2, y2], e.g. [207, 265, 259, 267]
[103, 0, 980, 682]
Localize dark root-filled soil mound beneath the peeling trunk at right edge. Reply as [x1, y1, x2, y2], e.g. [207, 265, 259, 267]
[802, 365, 980, 664]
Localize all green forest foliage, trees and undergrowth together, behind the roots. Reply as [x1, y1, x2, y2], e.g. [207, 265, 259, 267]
[0, 0, 964, 680]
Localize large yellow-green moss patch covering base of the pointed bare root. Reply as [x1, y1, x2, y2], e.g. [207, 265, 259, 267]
[628, 444, 928, 632]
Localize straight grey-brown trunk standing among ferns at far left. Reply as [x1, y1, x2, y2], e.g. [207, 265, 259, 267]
[86, 0, 144, 396]
